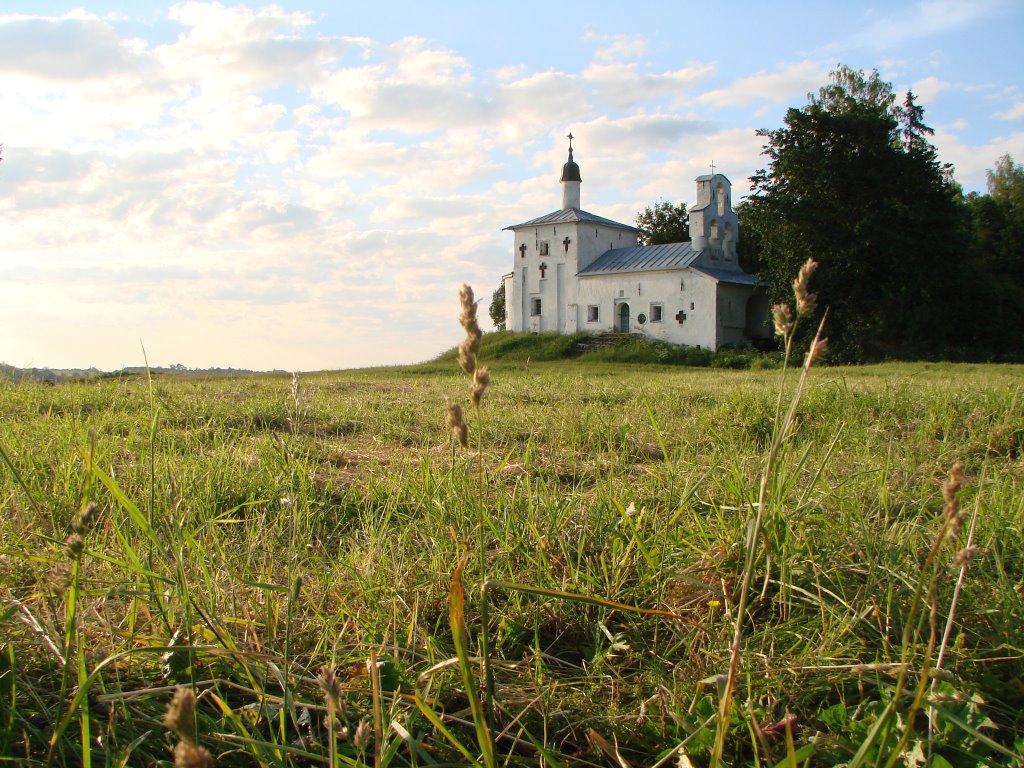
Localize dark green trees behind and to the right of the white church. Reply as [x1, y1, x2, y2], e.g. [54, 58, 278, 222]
[636, 67, 1024, 362]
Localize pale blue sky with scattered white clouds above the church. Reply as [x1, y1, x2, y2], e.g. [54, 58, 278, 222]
[0, 0, 1024, 371]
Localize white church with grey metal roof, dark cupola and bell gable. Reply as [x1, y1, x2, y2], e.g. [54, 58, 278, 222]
[503, 136, 772, 350]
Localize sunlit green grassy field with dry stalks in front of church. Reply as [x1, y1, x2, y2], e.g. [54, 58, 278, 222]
[0, 352, 1024, 768]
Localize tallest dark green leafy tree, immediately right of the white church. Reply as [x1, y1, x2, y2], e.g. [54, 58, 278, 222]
[742, 67, 966, 361]
